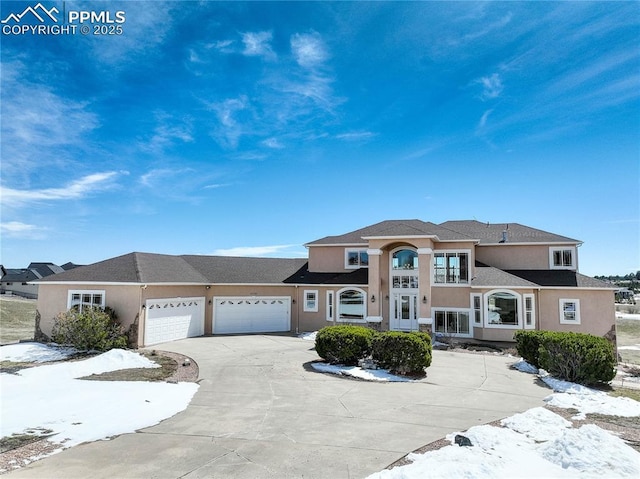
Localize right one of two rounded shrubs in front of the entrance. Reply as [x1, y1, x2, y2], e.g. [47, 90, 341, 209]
[371, 331, 431, 374]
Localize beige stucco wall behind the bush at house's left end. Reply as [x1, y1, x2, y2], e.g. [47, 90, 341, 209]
[38, 283, 141, 342]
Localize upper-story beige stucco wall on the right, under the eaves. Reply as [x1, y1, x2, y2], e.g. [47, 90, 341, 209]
[476, 243, 578, 269]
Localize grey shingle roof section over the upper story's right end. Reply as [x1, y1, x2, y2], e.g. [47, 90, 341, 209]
[440, 220, 581, 244]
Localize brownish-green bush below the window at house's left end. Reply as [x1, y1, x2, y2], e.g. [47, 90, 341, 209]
[51, 308, 127, 351]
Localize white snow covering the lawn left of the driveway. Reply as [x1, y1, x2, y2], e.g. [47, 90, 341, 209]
[0, 344, 198, 451]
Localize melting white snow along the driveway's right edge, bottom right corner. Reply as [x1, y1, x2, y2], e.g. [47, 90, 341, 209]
[369, 360, 640, 479]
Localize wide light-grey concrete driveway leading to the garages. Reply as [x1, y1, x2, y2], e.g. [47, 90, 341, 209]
[8, 335, 550, 479]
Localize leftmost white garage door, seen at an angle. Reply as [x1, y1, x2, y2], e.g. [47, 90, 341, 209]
[144, 298, 205, 346]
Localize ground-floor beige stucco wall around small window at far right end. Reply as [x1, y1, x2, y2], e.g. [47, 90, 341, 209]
[538, 289, 616, 336]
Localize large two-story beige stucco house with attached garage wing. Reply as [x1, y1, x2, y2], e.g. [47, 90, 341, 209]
[38, 220, 615, 345]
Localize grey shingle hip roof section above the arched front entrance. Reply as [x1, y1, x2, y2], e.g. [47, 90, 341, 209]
[306, 220, 471, 246]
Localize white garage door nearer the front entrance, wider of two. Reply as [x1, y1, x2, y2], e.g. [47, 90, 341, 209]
[213, 296, 291, 334]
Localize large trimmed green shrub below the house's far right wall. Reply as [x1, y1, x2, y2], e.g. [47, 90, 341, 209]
[539, 331, 616, 385]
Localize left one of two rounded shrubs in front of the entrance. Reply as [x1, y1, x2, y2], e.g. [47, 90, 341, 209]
[316, 325, 375, 365]
